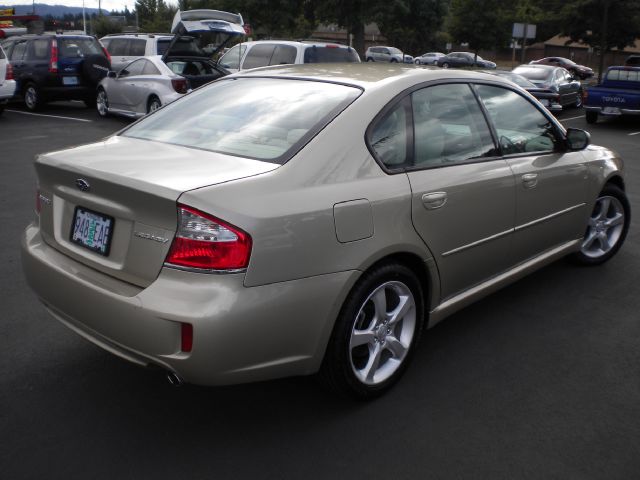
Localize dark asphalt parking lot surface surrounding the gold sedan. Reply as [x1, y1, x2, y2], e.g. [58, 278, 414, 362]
[0, 99, 640, 480]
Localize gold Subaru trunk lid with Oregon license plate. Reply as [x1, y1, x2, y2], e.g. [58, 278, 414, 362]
[36, 136, 278, 287]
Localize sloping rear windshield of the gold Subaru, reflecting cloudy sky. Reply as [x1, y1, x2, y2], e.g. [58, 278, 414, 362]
[122, 78, 360, 163]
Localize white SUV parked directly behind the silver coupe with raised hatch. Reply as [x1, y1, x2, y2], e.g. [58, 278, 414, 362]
[100, 33, 173, 72]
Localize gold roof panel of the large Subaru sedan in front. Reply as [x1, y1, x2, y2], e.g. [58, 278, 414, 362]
[232, 63, 507, 90]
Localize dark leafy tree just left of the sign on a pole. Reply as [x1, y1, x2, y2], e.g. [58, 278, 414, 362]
[448, 0, 513, 56]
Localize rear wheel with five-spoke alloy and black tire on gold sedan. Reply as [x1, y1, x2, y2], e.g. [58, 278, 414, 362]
[319, 263, 424, 400]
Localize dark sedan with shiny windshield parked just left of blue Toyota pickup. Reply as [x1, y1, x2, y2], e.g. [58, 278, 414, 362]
[513, 64, 582, 108]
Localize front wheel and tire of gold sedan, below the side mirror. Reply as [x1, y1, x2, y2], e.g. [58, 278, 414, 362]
[570, 183, 631, 266]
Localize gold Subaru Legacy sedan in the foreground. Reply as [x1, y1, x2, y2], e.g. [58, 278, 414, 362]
[22, 63, 630, 398]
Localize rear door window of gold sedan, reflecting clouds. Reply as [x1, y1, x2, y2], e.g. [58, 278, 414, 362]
[411, 83, 497, 168]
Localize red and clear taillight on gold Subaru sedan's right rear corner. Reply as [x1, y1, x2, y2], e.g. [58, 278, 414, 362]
[165, 204, 251, 270]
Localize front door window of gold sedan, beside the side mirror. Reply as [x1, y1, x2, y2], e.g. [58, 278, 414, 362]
[476, 85, 560, 155]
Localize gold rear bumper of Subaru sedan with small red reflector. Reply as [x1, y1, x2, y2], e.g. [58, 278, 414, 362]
[22, 224, 357, 385]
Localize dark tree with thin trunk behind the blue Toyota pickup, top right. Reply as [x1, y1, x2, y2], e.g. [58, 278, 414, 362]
[560, 0, 640, 79]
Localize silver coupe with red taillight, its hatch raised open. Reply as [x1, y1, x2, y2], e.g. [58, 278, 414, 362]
[96, 55, 189, 118]
